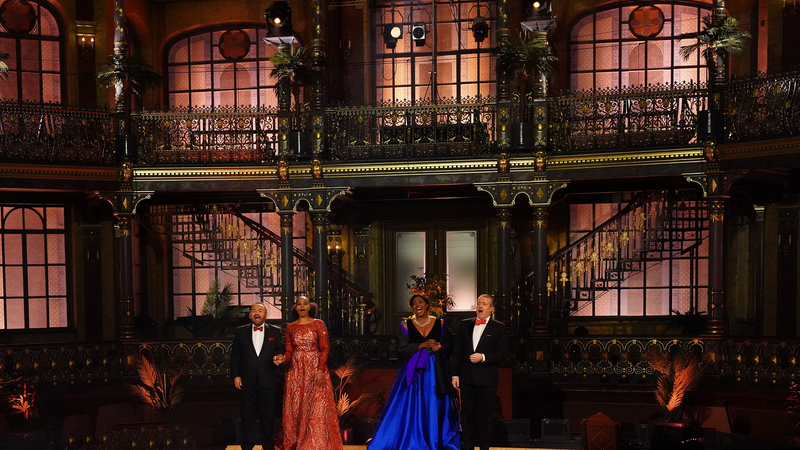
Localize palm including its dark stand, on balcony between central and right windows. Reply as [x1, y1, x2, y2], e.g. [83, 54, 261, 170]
[494, 32, 558, 147]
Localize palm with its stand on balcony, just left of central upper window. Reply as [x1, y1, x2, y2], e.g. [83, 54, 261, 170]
[269, 46, 316, 155]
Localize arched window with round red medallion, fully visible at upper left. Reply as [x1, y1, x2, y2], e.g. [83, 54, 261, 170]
[166, 25, 278, 108]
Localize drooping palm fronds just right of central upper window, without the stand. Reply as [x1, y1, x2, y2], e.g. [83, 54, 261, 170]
[494, 33, 558, 119]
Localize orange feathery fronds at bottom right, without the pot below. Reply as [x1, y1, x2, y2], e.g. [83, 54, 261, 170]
[649, 350, 707, 422]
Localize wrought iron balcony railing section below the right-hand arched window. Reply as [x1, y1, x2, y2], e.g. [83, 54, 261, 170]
[548, 83, 708, 152]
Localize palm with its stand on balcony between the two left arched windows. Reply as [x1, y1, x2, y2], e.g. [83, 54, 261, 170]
[97, 55, 161, 160]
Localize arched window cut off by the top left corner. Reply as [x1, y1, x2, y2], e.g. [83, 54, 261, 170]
[0, 0, 64, 103]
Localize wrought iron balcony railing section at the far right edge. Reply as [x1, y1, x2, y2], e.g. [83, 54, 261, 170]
[728, 72, 800, 141]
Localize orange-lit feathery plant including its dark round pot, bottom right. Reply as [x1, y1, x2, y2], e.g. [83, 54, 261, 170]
[648, 347, 707, 450]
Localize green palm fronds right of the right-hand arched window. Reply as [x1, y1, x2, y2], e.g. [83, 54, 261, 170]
[677, 15, 750, 65]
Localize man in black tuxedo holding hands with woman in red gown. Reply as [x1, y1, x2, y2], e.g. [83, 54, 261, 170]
[231, 303, 283, 450]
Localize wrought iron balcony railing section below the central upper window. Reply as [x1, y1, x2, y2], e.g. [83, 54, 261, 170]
[326, 98, 496, 161]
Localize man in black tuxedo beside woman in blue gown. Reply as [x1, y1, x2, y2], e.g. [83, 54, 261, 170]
[450, 294, 508, 450]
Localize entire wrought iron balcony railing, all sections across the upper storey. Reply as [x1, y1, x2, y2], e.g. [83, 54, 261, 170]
[0, 72, 800, 166]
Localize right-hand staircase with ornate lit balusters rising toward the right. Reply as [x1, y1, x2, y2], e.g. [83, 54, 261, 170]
[512, 192, 708, 327]
